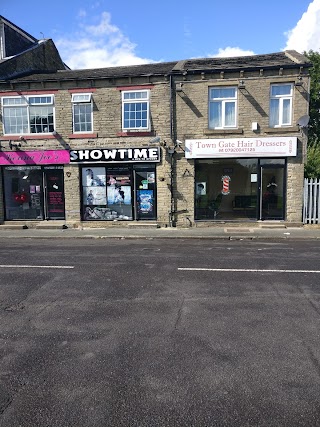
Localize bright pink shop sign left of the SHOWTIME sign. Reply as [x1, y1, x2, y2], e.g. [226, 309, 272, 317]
[0, 150, 70, 165]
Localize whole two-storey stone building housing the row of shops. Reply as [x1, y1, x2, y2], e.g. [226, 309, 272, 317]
[0, 18, 311, 227]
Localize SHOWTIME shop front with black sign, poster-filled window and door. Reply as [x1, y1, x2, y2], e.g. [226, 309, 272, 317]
[70, 147, 160, 221]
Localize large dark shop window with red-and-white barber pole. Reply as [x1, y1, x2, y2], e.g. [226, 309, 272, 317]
[195, 159, 258, 220]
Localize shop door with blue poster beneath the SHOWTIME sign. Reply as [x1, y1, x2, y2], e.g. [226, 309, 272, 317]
[134, 168, 156, 220]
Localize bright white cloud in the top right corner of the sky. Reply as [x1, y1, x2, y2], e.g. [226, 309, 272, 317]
[284, 0, 320, 53]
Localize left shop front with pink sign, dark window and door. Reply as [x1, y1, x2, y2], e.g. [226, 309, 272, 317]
[0, 150, 69, 221]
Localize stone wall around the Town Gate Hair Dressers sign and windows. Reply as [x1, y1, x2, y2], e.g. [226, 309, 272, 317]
[172, 69, 309, 226]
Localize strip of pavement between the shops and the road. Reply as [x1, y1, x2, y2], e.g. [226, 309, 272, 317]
[0, 223, 320, 240]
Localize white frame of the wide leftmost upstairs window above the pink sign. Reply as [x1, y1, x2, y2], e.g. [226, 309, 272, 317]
[1, 94, 55, 135]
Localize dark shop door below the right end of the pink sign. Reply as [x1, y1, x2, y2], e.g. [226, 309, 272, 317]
[43, 167, 65, 220]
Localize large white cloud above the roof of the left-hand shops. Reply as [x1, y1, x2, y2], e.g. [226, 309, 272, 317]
[55, 11, 154, 69]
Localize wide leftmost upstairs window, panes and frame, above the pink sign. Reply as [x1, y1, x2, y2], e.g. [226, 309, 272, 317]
[2, 95, 54, 134]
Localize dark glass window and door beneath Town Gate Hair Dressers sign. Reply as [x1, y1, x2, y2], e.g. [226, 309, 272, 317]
[195, 158, 285, 221]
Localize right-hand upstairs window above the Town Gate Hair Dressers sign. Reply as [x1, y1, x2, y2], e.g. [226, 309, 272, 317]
[270, 83, 293, 127]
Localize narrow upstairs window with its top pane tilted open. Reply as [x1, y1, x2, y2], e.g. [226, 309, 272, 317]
[72, 93, 93, 133]
